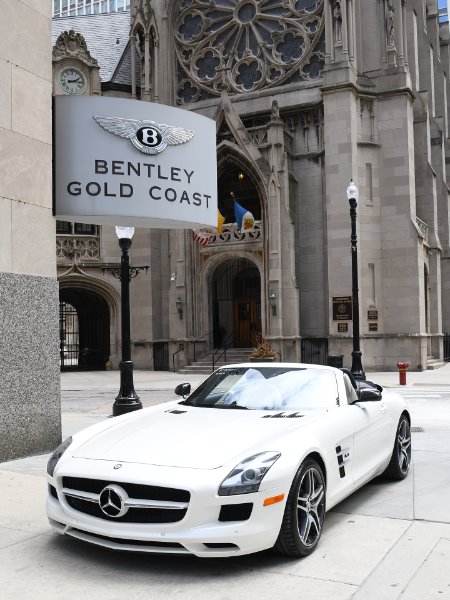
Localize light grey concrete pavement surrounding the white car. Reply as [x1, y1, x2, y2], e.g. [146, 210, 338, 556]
[0, 364, 450, 600]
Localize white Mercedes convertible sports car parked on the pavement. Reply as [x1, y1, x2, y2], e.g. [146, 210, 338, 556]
[47, 363, 411, 557]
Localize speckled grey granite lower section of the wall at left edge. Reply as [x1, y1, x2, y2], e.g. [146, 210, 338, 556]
[0, 273, 61, 461]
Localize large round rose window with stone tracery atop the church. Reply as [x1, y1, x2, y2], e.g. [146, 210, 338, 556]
[175, 0, 324, 104]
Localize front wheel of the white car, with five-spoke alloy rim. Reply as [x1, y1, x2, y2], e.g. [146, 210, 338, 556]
[274, 458, 325, 557]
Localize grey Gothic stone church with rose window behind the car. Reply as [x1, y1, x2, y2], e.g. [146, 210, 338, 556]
[53, 0, 450, 370]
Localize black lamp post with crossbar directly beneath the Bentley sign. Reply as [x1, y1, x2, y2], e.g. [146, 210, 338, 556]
[103, 227, 148, 417]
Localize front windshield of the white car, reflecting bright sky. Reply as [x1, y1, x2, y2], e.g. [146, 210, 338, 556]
[182, 367, 338, 411]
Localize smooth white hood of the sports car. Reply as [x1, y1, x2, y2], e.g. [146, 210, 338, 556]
[73, 403, 323, 469]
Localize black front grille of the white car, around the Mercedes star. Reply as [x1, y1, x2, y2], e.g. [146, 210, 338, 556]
[62, 477, 191, 523]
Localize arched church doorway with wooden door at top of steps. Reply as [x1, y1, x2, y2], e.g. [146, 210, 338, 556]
[212, 258, 261, 348]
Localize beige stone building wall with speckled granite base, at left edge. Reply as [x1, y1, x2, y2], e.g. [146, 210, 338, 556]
[0, 0, 61, 461]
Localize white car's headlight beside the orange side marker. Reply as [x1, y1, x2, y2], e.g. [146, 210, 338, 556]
[219, 452, 281, 496]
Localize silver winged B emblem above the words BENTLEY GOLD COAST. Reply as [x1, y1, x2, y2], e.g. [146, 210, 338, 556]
[92, 116, 195, 154]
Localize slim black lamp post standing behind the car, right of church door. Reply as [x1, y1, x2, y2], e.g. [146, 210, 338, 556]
[347, 180, 366, 381]
